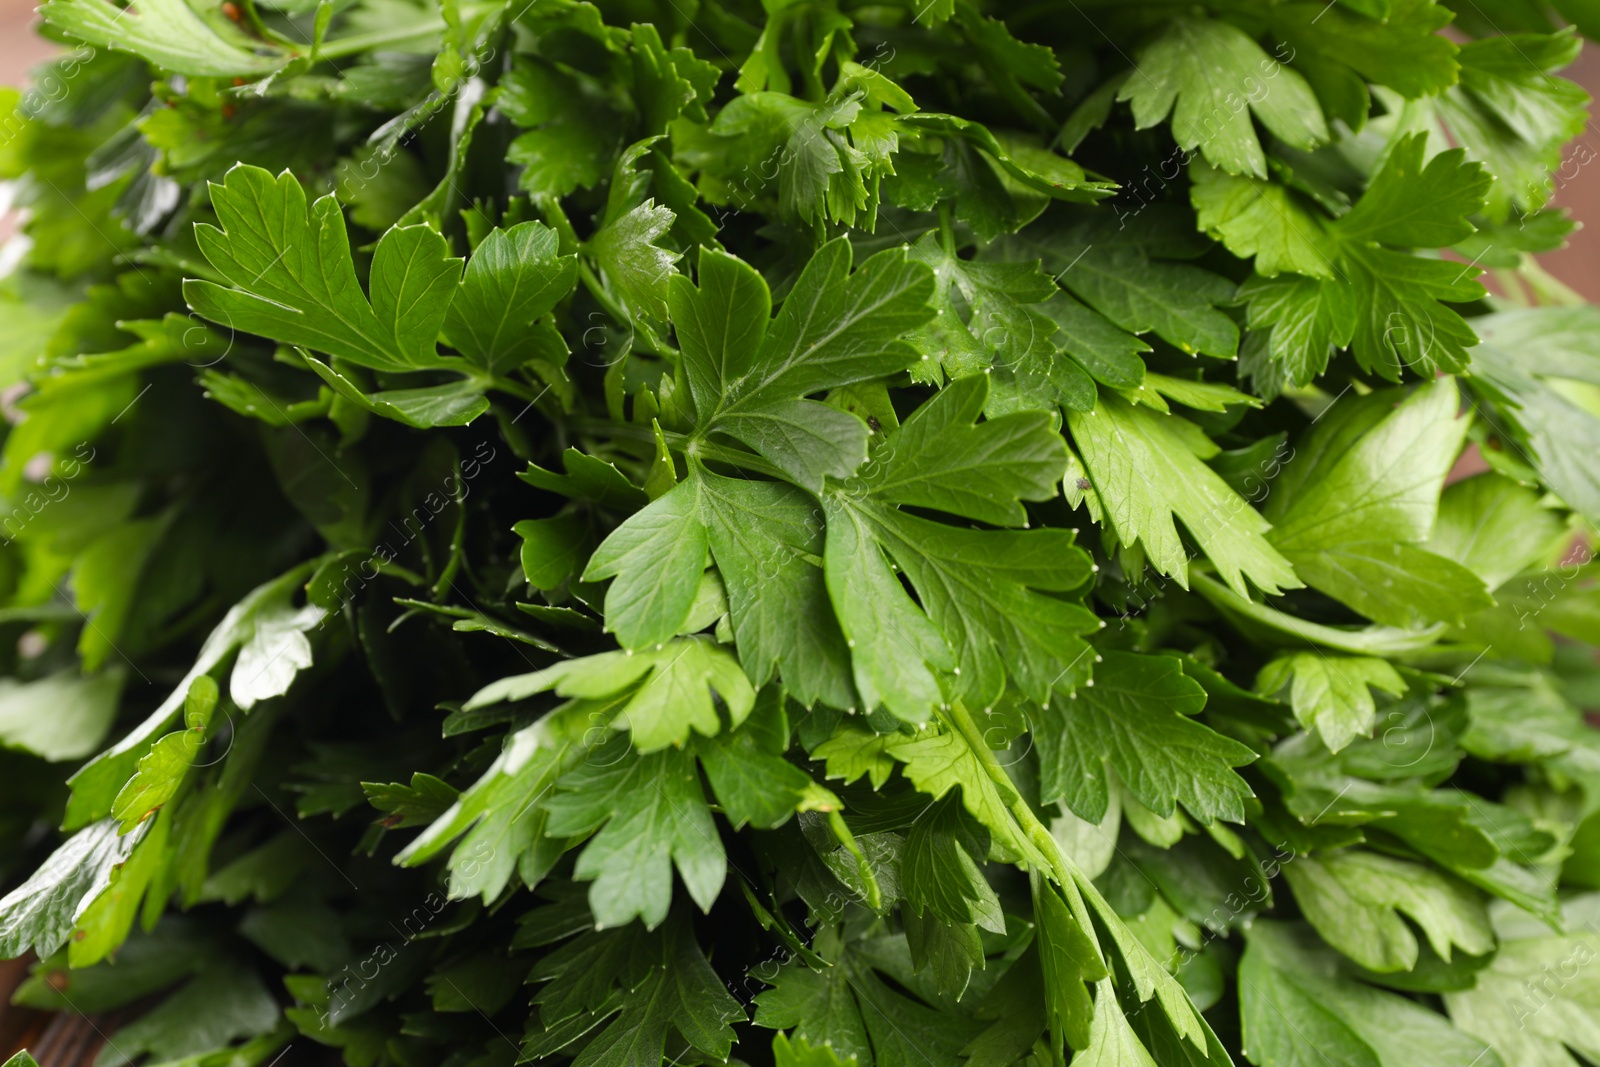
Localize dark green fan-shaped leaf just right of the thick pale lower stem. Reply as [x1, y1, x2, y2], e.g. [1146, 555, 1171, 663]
[1034, 653, 1256, 822]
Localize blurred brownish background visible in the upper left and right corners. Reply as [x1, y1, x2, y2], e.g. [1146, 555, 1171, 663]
[0, 0, 1600, 294]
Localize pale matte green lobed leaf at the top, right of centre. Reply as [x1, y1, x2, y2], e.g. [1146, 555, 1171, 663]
[1117, 18, 1328, 178]
